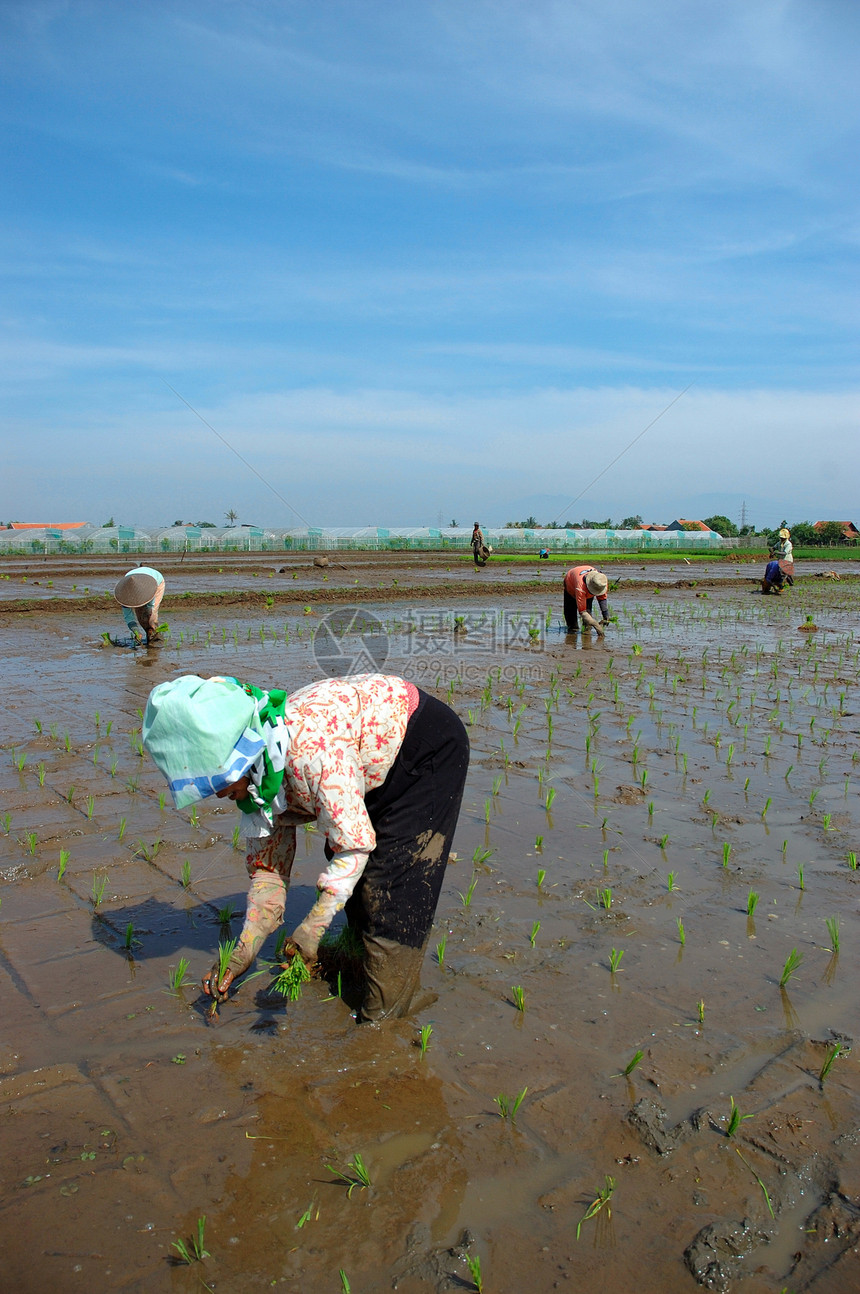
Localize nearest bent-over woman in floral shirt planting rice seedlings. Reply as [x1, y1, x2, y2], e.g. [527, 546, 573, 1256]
[142, 674, 469, 1021]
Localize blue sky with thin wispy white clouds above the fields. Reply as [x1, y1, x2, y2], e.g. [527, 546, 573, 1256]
[0, 0, 860, 525]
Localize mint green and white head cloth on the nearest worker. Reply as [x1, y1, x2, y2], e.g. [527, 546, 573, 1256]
[142, 674, 290, 835]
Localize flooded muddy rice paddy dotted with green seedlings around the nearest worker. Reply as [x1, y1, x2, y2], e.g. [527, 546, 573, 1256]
[0, 584, 860, 1294]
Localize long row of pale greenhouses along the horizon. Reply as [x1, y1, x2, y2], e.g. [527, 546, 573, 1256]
[0, 525, 733, 554]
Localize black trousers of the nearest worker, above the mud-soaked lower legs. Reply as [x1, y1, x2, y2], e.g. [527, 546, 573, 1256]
[345, 691, 469, 949]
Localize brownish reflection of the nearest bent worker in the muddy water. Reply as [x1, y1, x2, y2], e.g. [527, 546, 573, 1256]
[199, 1024, 468, 1289]
